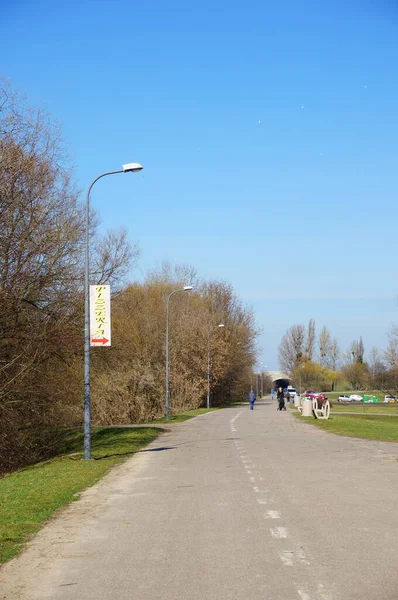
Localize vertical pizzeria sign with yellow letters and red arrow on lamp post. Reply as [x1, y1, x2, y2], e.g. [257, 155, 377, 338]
[90, 285, 111, 346]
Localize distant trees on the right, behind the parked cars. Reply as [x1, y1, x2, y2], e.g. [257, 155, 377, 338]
[278, 319, 398, 396]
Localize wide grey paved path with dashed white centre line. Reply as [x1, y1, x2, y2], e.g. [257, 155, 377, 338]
[0, 403, 398, 600]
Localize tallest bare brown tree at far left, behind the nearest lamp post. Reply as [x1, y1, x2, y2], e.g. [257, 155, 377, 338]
[0, 80, 134, 469]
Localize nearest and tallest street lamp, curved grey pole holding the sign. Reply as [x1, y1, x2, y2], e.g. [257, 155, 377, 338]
[84, 163, 143, 460]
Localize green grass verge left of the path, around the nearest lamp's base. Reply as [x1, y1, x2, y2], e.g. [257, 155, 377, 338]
[0, 427, 161, 562]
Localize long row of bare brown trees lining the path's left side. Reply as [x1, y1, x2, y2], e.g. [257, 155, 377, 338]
[0, 80, 257, 472]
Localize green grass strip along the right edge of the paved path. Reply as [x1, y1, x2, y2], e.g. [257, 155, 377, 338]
[294, 412, 398, 442]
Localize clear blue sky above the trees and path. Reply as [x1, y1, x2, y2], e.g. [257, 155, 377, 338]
[0, 0, 398, 369]
